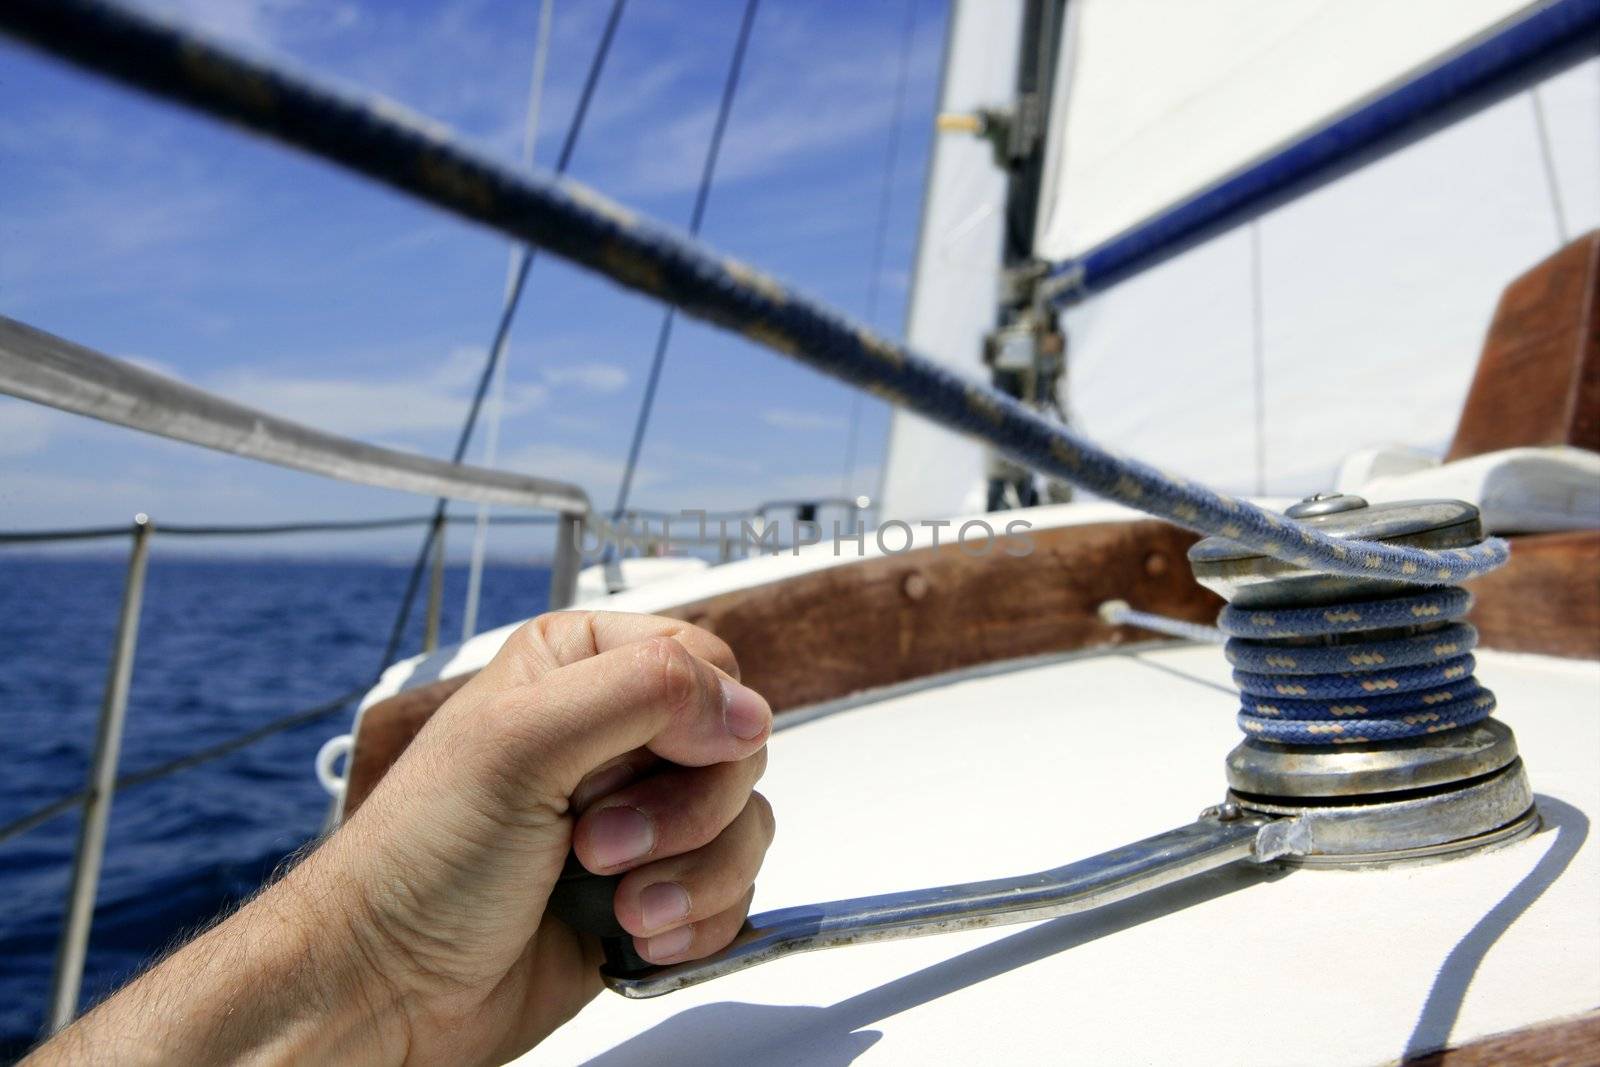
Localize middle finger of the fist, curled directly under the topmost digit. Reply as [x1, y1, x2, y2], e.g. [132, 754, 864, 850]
[573, 749, 766, 870]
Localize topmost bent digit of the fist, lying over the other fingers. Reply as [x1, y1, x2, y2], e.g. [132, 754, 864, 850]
[477, 633, 773, 803]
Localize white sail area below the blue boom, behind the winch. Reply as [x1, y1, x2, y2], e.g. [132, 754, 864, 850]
[1066, 61, 1600, 494]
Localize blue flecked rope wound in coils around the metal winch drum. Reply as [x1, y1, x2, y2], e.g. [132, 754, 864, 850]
[1218, 585, 1494, 745]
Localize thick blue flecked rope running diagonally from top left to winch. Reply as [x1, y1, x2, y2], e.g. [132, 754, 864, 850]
[0, 0, 1507, 584]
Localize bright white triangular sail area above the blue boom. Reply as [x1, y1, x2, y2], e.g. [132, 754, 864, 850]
[1035, 0, 1539, 259]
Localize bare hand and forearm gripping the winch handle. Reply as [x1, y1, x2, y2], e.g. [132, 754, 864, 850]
[29, 611, 773, 1064]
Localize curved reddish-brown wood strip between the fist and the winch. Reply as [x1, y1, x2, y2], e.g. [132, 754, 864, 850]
[667, 522, 1222, 710]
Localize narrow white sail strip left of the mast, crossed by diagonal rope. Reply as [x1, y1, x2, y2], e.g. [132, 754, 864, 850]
[878, 0, 1022, 522]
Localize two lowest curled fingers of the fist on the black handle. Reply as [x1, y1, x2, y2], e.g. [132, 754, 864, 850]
[614, 793, 773, 963]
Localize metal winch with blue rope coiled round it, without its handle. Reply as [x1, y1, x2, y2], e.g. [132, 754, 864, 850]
[1189, 493, 1538, 865]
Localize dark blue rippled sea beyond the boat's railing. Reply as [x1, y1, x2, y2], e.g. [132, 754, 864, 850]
[0, 556, 549, 1062]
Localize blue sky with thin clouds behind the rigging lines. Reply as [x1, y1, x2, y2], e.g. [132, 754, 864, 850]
[0, 0, 946, 557]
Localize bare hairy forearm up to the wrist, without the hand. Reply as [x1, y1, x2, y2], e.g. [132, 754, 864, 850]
[29, 857, 406, 1064]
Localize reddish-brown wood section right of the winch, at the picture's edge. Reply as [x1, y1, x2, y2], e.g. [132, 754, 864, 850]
[1469, 530, 1600, 659]
